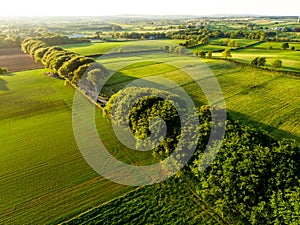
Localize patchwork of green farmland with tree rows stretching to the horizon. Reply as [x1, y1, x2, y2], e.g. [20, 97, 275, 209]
[0, 14, 300, 225]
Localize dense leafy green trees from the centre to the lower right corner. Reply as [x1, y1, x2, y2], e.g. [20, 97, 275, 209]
[106, 90, 300, 224]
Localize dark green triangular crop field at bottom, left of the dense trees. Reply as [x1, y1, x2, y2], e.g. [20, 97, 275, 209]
[63, 178, 225, 225]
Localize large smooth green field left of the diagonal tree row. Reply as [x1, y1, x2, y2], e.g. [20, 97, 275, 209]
[0, 69, 159, 224]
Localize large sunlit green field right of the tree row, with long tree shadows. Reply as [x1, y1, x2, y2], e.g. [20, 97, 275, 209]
[94, 49, 300, 140]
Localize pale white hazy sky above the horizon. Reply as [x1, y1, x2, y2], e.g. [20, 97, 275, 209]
[0, 0, 300, 16]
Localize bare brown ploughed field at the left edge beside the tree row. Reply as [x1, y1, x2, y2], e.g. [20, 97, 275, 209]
[0, 48, 43, 72]
